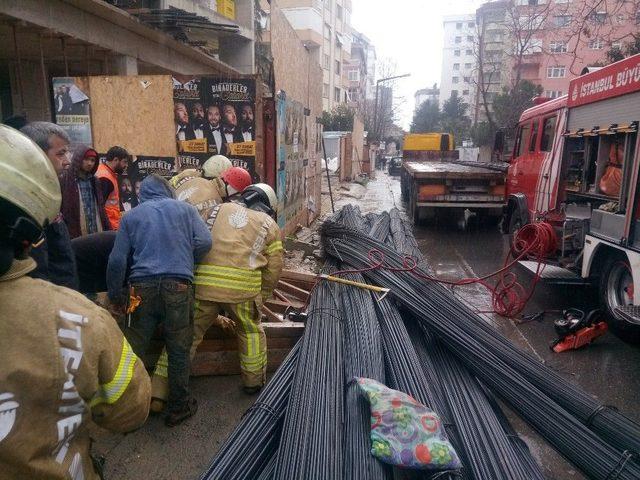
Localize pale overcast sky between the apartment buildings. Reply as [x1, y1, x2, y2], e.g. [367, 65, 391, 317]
[351, 0, 486, 128]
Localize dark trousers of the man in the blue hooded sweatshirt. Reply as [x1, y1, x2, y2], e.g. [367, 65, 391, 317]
[125, 277, 193, 412]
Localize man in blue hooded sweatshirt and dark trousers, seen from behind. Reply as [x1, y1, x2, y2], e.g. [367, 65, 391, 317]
[107, 175, 212, 427]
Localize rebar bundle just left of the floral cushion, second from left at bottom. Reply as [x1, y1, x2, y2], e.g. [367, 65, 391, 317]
[273, 282, 345, 480]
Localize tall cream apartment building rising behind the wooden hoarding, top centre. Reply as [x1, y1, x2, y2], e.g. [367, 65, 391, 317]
[277, 0, 352, 111]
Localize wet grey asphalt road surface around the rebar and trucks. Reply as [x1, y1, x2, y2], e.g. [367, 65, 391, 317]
[94, 172, 640, 480]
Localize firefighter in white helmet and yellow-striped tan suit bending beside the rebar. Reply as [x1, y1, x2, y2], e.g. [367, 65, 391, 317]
[151, 183, 283, 406]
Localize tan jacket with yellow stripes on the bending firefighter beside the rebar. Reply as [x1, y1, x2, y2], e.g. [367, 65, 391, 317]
[193, 203, 282, 303]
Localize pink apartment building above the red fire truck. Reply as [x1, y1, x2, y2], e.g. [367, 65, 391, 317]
[512, 0, 640, 98]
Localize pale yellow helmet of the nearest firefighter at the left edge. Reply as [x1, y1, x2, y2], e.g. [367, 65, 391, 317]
[0, 125, 62, 227]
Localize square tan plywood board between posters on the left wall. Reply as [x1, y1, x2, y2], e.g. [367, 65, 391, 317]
[88, 75, 176, 157]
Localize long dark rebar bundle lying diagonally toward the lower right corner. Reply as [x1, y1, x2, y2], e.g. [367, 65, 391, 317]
[323, 221, 640, 479]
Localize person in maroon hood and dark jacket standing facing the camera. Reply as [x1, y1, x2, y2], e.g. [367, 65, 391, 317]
[60, 145, 110, 239]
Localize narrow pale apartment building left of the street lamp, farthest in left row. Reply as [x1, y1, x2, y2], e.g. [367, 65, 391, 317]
[343, 31, 376, 107]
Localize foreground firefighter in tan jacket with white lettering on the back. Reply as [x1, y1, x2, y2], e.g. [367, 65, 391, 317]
[0, 126, 150, 480]
